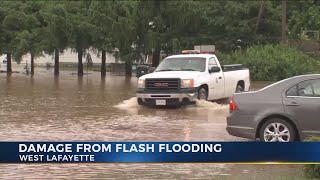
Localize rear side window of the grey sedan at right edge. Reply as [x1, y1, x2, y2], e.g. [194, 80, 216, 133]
[286, 79, 320, 97]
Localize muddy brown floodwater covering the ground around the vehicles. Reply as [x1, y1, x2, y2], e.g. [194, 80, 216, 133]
[0, 69, 302, 179]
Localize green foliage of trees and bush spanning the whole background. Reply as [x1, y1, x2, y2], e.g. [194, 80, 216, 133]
[0, 0, 320, 74]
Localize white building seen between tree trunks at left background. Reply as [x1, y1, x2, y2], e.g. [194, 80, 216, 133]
[0, 49, 118, 69]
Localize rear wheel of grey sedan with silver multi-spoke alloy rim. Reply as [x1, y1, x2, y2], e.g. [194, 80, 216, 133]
[260, 118, 295, 142]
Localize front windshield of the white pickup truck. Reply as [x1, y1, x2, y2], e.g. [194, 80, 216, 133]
[155, 57, 206, 72]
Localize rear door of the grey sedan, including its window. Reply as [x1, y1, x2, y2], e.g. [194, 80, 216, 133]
[284, 79, 320, 135]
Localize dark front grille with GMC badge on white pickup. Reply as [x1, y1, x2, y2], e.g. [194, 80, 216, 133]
[146, 78, 180, 91]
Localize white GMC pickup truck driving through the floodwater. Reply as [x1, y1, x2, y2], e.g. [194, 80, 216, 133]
[137, 51, 250, 106]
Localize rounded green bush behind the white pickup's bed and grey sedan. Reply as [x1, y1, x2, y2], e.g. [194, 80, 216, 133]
[217, 44, 320, 81]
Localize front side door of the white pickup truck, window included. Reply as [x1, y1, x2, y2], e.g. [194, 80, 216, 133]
[208, 57, 224, 100]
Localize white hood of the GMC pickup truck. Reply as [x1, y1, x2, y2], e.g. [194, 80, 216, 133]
[139, 71, 201, 79]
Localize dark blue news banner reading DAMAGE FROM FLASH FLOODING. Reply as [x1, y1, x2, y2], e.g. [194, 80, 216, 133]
[0, 142, 320, 163]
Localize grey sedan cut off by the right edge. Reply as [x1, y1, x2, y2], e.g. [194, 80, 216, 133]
[227, 74, 320, 142]
